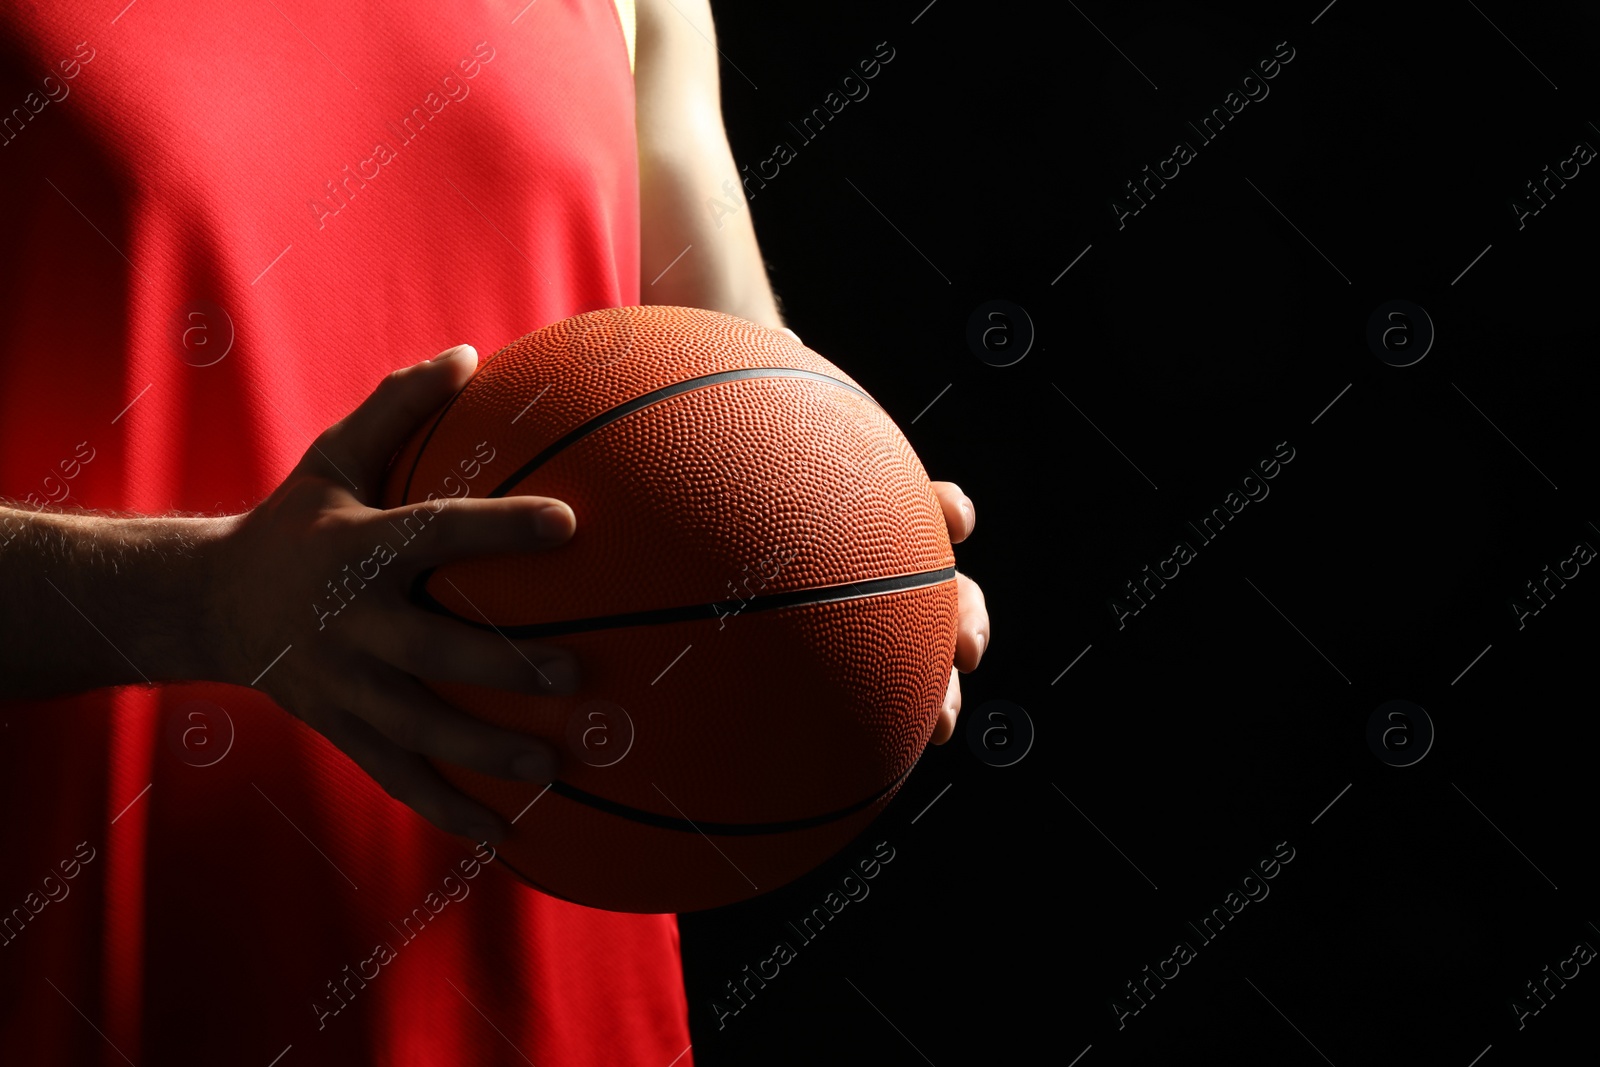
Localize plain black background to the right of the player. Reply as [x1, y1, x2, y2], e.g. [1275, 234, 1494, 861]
[682, 0, 1600, 1067]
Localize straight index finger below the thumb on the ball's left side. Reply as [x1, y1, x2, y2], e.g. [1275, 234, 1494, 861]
[371, 496, 578, 573]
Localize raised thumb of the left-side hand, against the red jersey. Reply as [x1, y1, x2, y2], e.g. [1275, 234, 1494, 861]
[315, 344, 478, 499]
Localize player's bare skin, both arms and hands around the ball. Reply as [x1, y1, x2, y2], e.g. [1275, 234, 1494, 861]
[0, 0, 990, 841]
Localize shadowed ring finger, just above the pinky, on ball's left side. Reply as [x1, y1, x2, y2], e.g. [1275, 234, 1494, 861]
[349, 664, 560, 782]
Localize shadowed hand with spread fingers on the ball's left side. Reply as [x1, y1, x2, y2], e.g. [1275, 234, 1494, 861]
[206, 346, 578, 841]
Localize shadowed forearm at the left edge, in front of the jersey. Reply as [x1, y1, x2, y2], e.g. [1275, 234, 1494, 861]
[0, 504, 232, 699]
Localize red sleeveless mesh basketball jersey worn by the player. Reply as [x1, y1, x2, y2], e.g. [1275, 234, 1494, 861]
[0, 0, 691, 1067]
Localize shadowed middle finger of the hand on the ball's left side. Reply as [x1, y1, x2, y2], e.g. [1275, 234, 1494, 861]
[371, 608, 578, 696]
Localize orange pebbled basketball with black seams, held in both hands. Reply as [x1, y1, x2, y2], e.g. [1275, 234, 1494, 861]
[384, 307, 957, 912]
